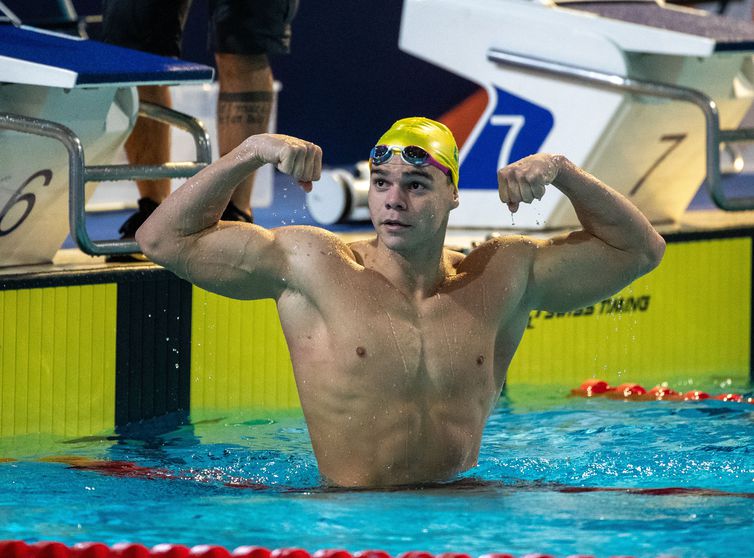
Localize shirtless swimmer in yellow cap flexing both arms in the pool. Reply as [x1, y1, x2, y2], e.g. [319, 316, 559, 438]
[136, 117, 665, 487]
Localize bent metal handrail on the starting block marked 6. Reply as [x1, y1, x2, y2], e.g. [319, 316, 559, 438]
[0, 103, 212, 256]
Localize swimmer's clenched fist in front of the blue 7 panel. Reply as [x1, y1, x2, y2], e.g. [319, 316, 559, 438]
[497, 153, 561, 213]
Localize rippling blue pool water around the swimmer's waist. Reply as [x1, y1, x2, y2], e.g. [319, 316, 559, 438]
[0, 386, 754, 558]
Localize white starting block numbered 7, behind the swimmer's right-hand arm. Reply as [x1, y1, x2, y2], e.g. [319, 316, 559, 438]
[400, 0, 754, 230]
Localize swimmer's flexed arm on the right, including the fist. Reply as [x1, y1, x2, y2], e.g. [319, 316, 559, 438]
[499, 154, 665, 312]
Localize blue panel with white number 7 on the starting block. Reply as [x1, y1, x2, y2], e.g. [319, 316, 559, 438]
[459, 88, 553, 190]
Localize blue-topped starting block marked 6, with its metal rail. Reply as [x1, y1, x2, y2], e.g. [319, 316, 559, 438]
[0, 25, 214, 266]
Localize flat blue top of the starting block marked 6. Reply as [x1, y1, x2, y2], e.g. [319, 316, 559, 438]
[0, 25, 213, 85]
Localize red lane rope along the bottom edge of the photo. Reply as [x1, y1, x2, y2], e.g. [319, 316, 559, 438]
[0, 541, 633, 558]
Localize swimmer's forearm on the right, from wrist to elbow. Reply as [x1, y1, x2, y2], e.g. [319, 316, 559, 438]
[552, 155, 665, 267]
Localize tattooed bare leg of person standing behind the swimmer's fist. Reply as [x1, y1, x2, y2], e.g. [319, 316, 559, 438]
[215, 53, 273, 218]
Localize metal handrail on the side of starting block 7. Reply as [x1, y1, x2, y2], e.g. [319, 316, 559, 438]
[487, 48, 754, 211]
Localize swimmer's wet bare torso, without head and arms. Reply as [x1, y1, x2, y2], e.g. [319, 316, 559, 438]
[278, 234, 528, 486]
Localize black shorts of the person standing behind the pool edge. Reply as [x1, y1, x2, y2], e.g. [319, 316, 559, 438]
[101, 0, 298, 57]
